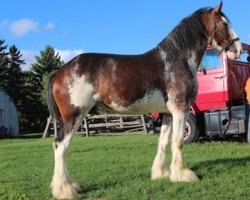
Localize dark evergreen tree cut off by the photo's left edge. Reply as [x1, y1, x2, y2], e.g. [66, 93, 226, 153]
[0, 40, 9, 90]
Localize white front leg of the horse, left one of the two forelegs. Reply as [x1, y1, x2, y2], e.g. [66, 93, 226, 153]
[151, 114, 172, 179]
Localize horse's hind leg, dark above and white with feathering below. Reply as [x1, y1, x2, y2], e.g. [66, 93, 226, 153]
[51, 109, 90, 199]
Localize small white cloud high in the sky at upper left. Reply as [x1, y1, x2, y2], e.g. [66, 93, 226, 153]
[9, 18, 55, 37]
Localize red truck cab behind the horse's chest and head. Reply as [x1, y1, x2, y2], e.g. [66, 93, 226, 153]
[193, 46, 250, 113]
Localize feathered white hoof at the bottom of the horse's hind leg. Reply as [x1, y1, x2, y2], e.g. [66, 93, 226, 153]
[50, 181, 81, 199]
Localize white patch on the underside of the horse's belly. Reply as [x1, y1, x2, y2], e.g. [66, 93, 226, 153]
[109, 90, 167, 114]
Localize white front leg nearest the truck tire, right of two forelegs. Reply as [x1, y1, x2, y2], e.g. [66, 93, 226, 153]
[170, 110, 199, 182]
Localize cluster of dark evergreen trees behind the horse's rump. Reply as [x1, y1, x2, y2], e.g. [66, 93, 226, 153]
[0, 40, 63, 132]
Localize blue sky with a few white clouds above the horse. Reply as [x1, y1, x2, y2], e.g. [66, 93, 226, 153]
[0, 0, 250, 69]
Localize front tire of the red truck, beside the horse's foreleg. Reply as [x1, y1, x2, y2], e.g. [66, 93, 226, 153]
[184, 114, 198, 144]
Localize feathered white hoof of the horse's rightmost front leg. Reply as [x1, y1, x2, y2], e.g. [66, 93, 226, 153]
[170, 169, 199, 182]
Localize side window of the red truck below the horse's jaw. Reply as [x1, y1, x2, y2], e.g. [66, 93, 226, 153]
[199, 49, 220, 70]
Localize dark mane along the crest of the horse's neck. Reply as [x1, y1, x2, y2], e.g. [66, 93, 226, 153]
[158, 7, 228, 52]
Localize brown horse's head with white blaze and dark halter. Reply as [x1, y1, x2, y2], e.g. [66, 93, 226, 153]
[202, 2, 242, 59]
